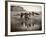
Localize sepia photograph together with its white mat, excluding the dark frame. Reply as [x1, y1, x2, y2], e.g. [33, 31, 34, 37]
[5, 2, 44, 35]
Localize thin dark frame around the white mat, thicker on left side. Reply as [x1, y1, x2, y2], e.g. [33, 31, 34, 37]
[5, 1, 45, 36]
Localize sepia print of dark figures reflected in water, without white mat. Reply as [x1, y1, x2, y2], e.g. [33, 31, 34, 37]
[11, 5, 42, 32]
